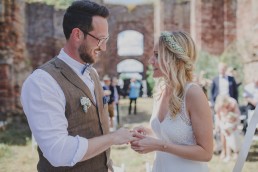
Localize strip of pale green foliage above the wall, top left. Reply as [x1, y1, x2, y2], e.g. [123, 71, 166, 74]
[26, 0, 73, 9]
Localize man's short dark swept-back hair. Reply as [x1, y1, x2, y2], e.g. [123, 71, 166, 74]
[63, 0, 109, 39]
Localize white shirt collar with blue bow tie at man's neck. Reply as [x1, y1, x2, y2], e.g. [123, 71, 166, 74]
[57, 48, 92, 75]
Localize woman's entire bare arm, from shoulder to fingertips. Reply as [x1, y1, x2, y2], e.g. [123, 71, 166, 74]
[132, 86, 213, 161]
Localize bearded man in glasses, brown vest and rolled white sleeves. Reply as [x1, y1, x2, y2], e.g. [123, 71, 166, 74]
[21, 0, 134, 172]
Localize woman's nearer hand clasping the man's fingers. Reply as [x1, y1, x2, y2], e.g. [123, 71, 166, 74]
[131, 133, 160, 154]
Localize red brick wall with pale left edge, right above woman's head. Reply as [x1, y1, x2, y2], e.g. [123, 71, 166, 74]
[191, 0, 237, 55]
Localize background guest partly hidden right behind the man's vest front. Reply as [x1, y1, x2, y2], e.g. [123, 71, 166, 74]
[103, 75, 115, 130]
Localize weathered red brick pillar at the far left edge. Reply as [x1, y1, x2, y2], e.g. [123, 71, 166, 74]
[0, 0, 28, 117]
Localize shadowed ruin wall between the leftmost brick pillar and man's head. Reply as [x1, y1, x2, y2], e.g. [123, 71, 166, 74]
[25, 3, 65, 69]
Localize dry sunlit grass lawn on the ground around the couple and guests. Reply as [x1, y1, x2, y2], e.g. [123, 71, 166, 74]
[0, 99, 258, 172]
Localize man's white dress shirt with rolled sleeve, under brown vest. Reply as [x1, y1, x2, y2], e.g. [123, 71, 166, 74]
[21, 49, 96, 167]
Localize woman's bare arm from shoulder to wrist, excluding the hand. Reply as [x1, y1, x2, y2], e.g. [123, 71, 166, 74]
[160, 86, 213, 161]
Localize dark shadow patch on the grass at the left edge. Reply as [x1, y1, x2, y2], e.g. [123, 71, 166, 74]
[0, 118, 31, 145]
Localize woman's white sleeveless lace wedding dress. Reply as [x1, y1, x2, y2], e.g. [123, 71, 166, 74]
[150, 83, 209, 172]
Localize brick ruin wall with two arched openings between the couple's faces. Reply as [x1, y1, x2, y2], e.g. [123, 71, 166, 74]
[95, 5, 154, 78]
